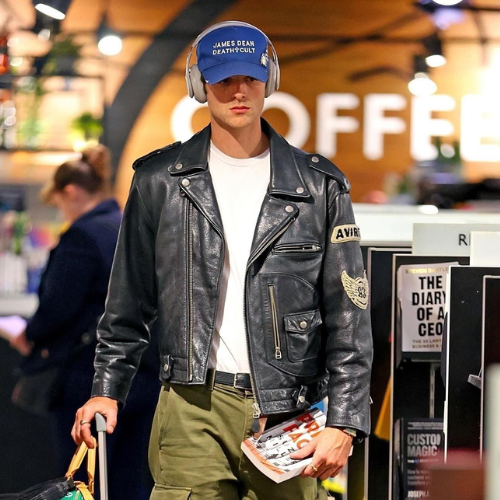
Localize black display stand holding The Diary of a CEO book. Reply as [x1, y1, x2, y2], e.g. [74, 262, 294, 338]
[389, 254, 469, 500]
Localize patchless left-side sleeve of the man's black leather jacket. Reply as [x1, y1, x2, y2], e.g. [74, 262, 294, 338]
[92, 173, 157, 405]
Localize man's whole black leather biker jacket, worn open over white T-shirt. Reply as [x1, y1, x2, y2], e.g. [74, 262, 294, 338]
[92, 120, 372, 434]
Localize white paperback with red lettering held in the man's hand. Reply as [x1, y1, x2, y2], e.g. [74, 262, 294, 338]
[241, 408, 326, 483]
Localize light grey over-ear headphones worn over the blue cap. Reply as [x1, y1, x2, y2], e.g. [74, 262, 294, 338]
[186, 21, 280, 103]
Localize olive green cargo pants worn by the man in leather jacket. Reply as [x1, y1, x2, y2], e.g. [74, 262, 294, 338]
[149, 384, 326, 500]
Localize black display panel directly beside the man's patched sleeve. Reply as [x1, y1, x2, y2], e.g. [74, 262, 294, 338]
[365, 247, 411, 500]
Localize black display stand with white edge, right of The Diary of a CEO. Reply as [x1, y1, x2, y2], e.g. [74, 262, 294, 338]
[444, 267, 500, 456]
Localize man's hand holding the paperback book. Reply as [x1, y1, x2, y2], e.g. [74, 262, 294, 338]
[290, 427, 352, 481]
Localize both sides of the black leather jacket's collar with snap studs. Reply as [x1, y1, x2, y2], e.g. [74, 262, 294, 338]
[168, 118, 311, 199]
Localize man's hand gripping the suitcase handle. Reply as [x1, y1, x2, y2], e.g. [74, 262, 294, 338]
[71, 397, 118, 448]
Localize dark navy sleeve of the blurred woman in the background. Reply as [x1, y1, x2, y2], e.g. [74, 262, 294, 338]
[26, 228, 100, 342]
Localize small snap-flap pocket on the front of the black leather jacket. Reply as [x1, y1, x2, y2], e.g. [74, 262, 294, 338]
[284, 309, 323, 362]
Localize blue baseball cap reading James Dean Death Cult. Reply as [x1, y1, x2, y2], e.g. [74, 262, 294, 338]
[196, 26, 269, 84]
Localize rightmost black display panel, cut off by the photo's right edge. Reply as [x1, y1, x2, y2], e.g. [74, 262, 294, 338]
[480, 276, 500, 455]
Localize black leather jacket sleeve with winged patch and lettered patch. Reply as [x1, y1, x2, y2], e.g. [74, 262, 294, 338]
[322, 180, 372, 436]
